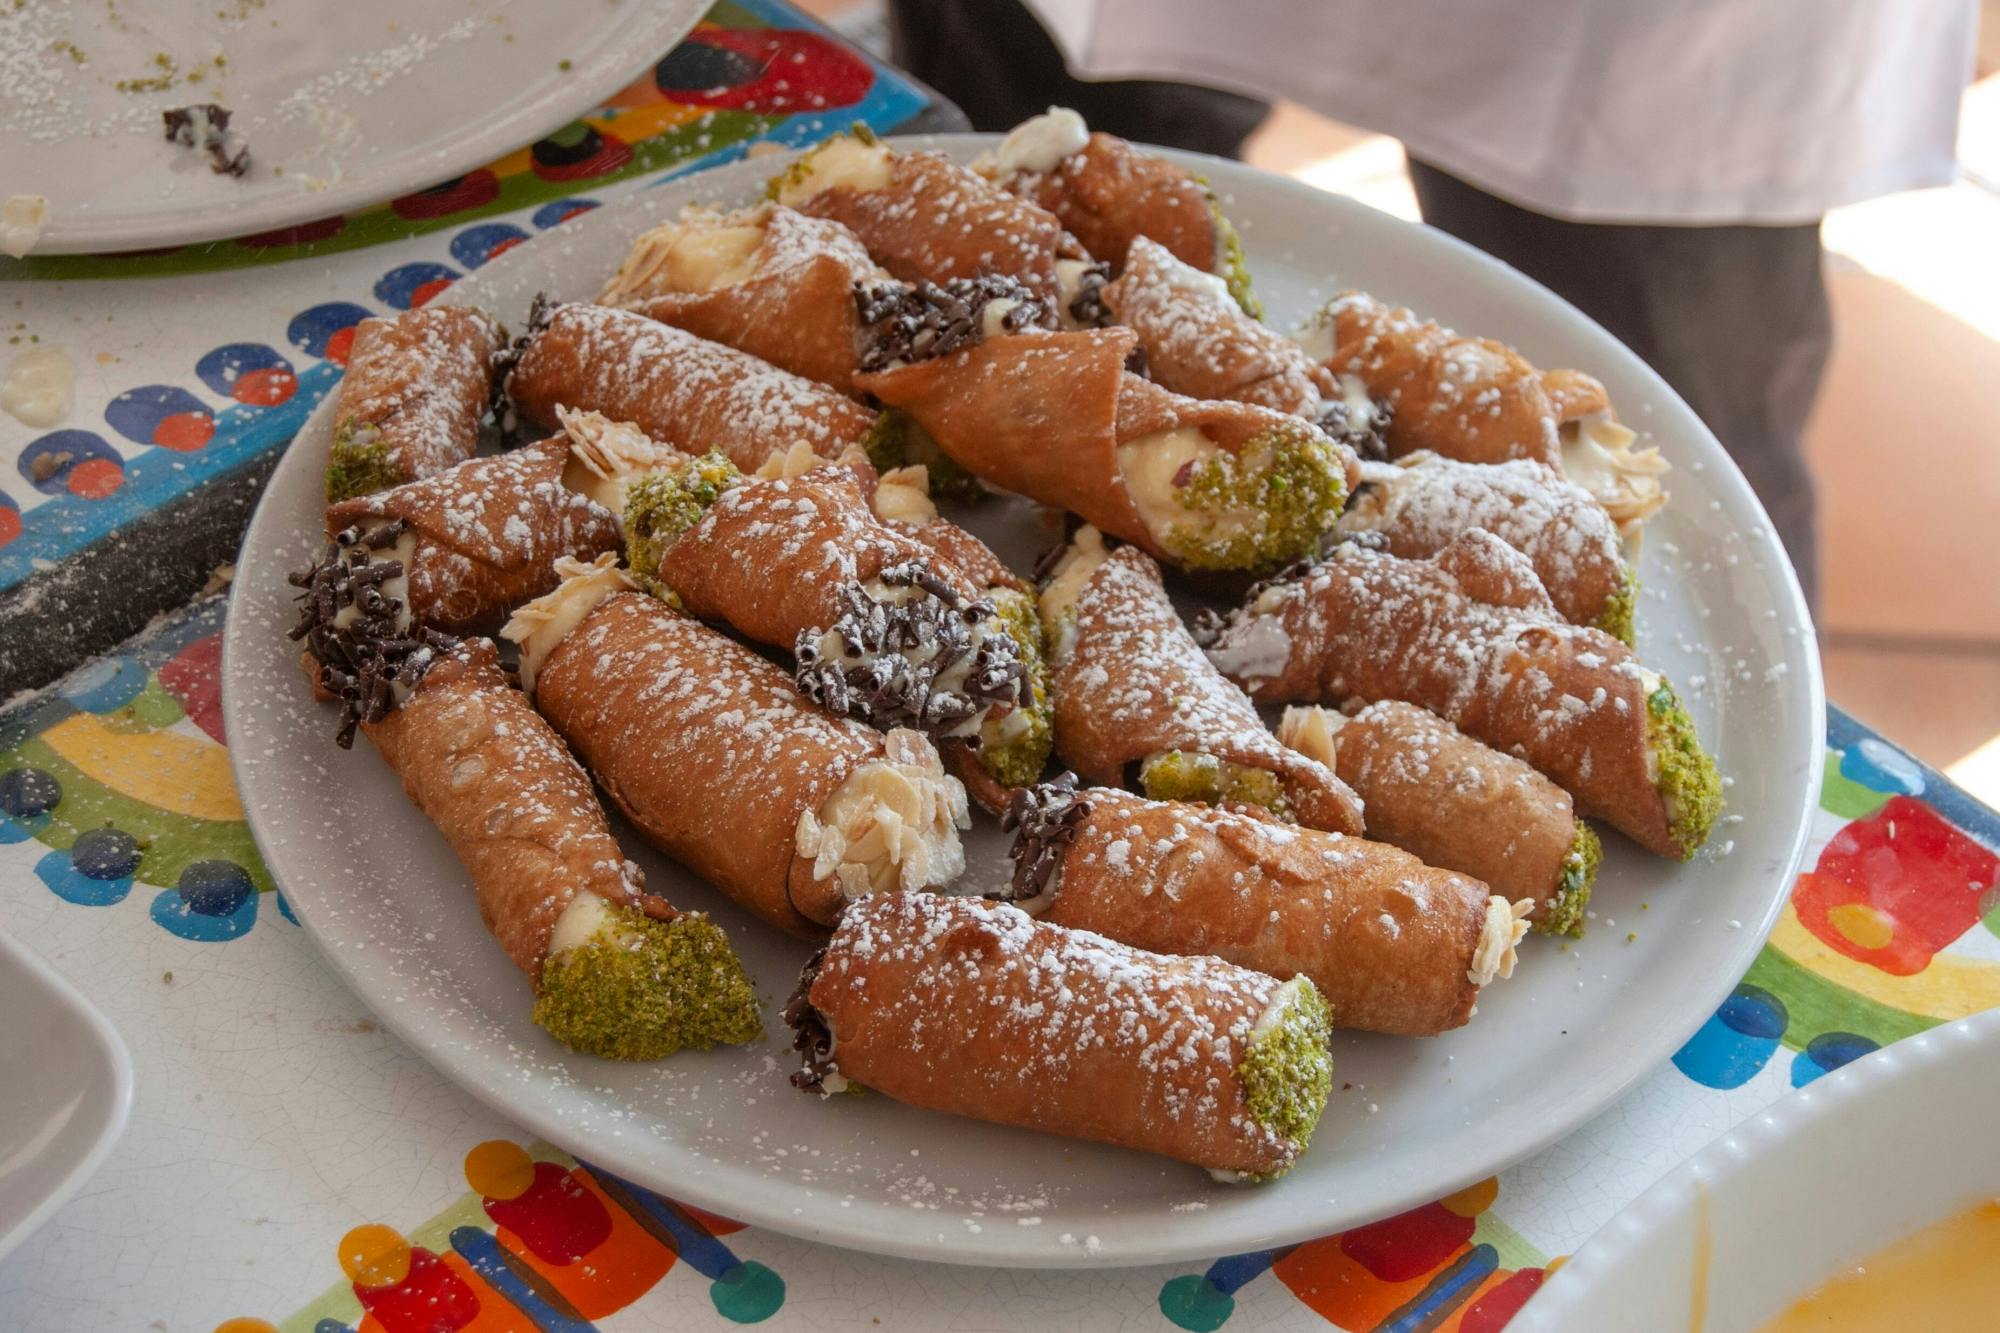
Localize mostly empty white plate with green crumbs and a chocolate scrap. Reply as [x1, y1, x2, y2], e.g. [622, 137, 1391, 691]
[0, 0, 708, 254]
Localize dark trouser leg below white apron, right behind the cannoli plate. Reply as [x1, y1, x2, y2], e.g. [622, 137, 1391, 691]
[1410, 158, 1832, 604]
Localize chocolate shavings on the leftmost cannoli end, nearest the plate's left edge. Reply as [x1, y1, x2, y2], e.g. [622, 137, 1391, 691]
[288, 518, 458, 749]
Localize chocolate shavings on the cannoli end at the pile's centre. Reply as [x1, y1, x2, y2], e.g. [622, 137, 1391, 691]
[792, 560, 1028, 743]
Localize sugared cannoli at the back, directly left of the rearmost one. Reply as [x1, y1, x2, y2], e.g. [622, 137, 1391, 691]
[768, 128, 1106, 322]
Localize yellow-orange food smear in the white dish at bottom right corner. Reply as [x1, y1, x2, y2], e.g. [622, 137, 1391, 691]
[1762, 1199, 2000, 1333]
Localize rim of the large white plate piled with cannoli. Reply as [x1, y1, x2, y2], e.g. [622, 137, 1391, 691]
[222, 134, 1826, 1269]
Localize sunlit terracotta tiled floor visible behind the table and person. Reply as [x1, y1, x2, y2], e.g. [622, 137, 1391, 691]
[800, 0, 2000, 805]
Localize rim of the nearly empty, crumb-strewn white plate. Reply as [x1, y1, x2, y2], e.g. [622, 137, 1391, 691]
[28, 0, 710, 258]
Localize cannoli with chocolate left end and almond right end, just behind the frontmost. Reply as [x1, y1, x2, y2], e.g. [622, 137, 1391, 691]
[1004, 775, 1530, 1037]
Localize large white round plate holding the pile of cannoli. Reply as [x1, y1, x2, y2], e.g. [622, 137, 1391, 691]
[224, 136, 1822, 1267]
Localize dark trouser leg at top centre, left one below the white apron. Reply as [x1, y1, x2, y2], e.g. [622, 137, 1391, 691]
[890, 0, 1270, 158]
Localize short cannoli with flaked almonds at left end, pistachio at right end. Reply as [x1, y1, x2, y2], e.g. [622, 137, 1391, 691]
[1278, 699, 1604, 935]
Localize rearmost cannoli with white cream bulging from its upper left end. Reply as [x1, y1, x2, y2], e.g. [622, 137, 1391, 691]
[974, 106, 1264, 318]
